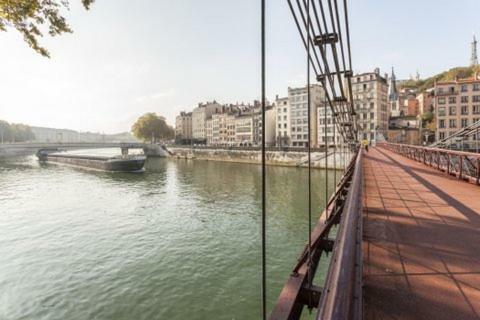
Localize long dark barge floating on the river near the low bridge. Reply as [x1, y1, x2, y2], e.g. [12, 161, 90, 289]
[37, 149, 146, 172]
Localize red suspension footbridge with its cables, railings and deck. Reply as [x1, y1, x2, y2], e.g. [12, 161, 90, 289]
[261, 0, 480, 320]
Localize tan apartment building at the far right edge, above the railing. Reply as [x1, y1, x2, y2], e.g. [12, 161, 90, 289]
[435, 74, 480, 140]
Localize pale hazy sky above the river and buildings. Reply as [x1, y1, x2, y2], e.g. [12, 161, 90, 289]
[0, 0, 480, 133]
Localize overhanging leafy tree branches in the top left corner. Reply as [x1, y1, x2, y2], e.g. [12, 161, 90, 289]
[0, 0, 95, 57]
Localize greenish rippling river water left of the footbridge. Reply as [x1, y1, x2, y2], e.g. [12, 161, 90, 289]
[0, 151, 334, 320]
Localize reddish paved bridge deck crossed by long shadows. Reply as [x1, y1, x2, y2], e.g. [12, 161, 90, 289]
[363, 148, 480, 319]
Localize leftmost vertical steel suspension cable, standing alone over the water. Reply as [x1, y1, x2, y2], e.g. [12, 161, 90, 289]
[261, 0, 267, 320]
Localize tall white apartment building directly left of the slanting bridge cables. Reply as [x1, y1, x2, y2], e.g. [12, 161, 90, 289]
[288, 84, 325, 147]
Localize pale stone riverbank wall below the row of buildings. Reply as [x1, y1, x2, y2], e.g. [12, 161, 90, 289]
[168, 147, 348, 170]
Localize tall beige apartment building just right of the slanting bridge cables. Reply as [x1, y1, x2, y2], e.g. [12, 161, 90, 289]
[352, 68, 390, 142]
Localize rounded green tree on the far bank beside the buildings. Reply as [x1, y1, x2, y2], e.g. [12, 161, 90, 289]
[132, 113, 175, 142]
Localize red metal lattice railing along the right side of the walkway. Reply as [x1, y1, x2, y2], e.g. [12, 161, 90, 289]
[378, 142, 480, 185]
